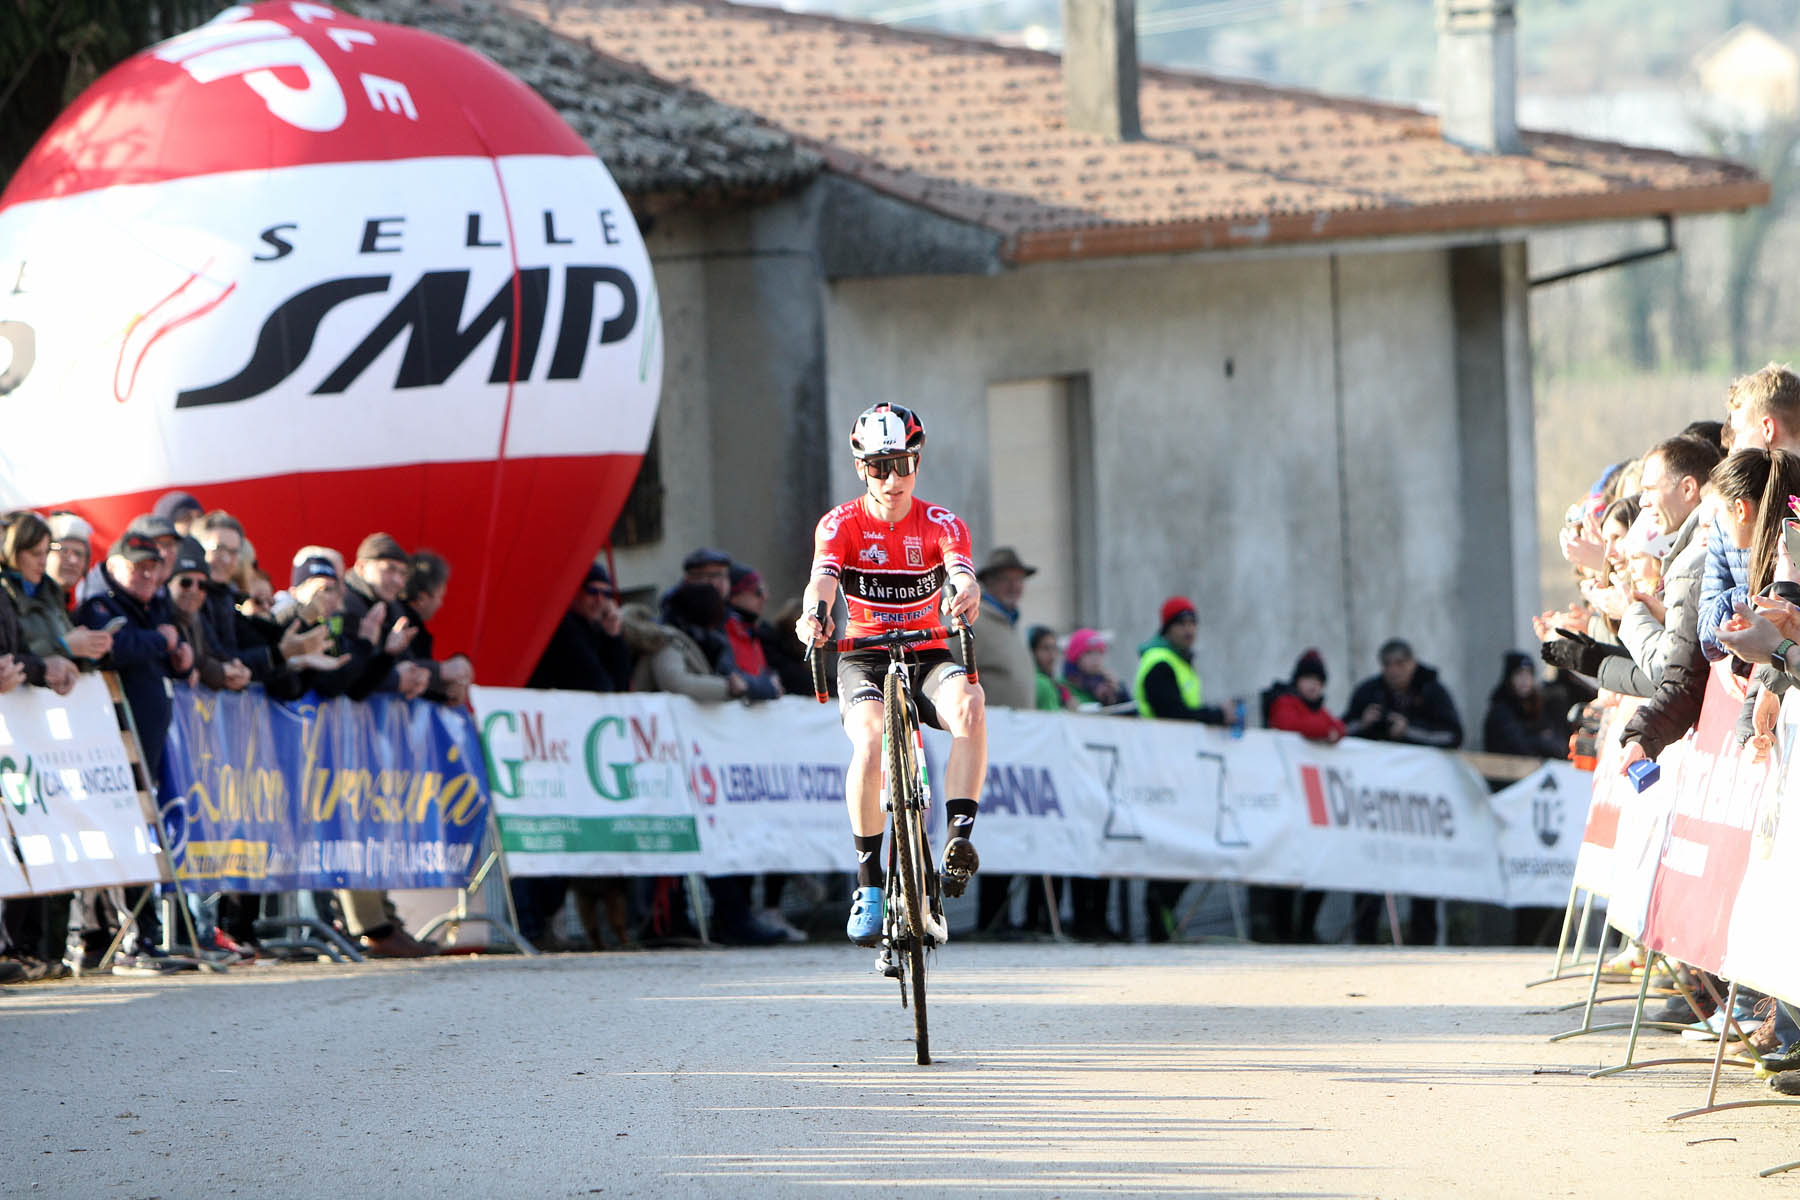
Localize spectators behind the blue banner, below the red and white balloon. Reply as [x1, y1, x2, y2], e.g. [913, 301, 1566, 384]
[0, 491, 475, 982]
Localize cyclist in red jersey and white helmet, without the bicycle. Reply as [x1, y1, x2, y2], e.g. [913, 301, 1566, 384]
[794, 405, 988, 946]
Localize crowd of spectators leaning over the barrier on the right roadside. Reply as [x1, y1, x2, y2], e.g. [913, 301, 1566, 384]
[1526, 363, 1800, 1094]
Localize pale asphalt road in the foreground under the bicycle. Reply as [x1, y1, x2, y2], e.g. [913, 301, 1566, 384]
[0, 945, 1800, 1198]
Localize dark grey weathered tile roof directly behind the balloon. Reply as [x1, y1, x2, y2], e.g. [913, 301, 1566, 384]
[369, 0, 821, 210]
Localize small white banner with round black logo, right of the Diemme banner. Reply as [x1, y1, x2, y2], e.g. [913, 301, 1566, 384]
[1489, 763, 1593, 909]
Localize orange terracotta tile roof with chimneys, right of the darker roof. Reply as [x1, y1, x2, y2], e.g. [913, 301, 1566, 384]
[504, 0, 1768, 261]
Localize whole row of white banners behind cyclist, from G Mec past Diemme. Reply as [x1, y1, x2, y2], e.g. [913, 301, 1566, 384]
[475, 687, 1588, 905]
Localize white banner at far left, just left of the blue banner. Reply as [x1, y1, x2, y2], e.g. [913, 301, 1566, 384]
[0, 675, 160, 894]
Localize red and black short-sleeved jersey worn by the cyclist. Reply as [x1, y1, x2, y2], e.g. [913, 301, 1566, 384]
[812, 497, 976, 648]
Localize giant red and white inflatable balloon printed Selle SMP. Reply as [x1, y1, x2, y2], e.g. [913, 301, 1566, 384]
[0, 2, 662, 684]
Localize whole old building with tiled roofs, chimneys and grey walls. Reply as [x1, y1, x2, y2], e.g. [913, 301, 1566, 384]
[376, 0, 1766, 727]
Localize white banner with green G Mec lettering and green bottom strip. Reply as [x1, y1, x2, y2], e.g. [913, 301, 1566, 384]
[473, 687, 707, 874]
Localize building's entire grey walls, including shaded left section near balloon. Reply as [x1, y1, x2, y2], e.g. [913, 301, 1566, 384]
[617, 189, 1537, 738]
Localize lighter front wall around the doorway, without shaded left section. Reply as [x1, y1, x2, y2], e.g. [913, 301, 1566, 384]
[826, 252, 1483, 725]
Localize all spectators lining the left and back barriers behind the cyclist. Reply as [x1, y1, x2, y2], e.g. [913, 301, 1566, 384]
[0, 460, 1648, 979]
